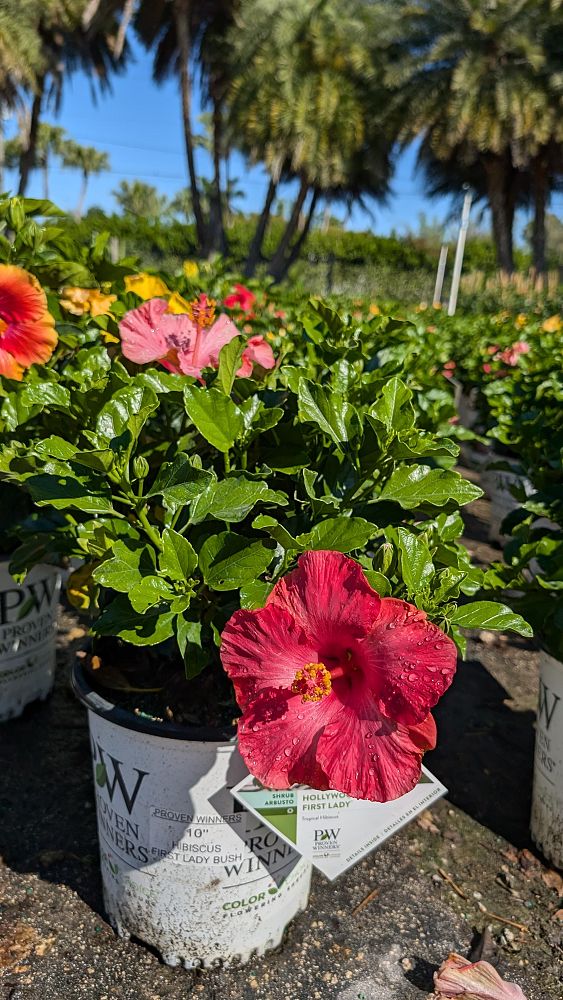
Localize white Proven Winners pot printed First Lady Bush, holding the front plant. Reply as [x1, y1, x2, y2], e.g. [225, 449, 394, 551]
[73, 664, 312, 968]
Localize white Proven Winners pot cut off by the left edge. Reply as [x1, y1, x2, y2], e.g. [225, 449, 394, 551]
[0, 559, 61, 722]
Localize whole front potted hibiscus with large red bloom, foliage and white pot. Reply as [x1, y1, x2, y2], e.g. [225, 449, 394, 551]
[2, 270, 530, 965]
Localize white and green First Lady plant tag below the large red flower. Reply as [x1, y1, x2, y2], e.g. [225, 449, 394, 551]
[231, 767, 447, 880]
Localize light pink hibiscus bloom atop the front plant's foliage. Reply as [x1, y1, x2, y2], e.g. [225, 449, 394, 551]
[119, 295, 275, 381]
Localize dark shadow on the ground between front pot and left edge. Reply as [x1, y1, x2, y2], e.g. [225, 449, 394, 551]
[0, 615, 103, 913]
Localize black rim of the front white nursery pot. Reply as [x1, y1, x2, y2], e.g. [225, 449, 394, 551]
[70, 657, 237, 744]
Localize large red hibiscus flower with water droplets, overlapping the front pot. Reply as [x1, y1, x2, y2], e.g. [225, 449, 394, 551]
[221, 551, 456, 802]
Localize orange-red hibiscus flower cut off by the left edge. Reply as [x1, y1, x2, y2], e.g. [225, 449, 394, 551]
[0, 264, 57, 382]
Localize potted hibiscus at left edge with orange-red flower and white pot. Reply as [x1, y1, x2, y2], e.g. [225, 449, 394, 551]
[0, 198, 139, 721]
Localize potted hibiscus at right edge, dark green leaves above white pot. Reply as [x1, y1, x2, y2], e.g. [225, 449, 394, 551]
[484, 367, 563, 867]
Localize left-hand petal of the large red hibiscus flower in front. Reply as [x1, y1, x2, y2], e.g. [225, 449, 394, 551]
[221, 607, 318, 709]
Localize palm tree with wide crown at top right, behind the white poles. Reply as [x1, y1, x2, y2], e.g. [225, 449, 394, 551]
[389, 0, 563, 272]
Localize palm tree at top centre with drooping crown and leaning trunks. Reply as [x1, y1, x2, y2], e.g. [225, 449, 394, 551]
[230, 0, 390, 280]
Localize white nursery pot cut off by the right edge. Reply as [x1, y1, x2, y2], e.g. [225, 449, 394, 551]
[531, 650, 563, 868]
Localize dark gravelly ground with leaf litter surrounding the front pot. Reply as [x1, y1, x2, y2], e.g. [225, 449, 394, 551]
[0, 472, 563, 1000]
